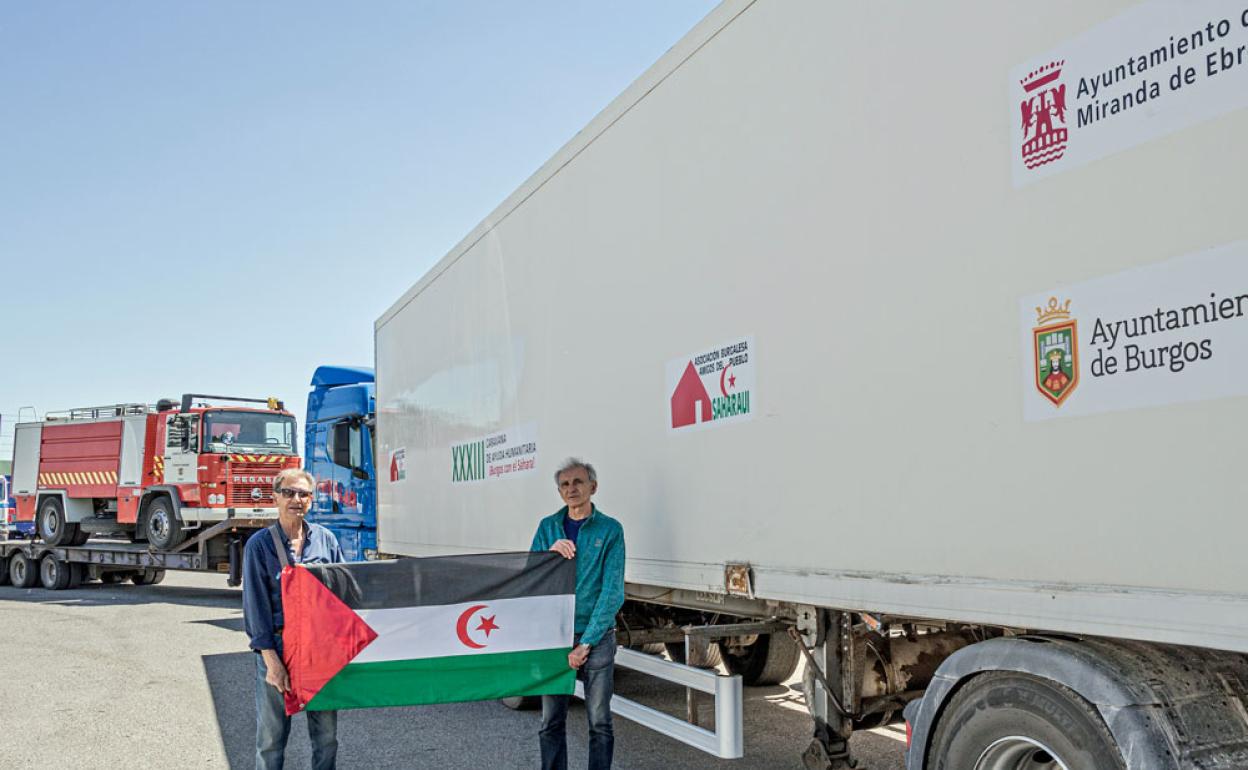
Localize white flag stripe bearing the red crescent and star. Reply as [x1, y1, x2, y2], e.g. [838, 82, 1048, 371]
[351, 594, 577, 663]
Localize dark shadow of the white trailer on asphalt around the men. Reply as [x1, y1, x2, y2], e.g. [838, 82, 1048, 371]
[201, 651, 901, 770]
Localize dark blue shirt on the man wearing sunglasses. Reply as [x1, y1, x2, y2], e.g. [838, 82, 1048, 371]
[242, 522, 347, 654]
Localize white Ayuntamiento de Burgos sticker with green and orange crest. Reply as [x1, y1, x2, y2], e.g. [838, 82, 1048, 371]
[1018, 241, 1248, 421]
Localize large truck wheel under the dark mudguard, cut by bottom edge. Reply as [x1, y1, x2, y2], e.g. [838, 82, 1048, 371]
[924, 671, 1126, 770]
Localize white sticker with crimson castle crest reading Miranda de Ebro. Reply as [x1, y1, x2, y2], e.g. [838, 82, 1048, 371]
[1006, 0, 1248, 187]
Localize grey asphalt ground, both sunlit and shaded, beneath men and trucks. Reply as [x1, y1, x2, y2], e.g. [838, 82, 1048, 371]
[0, 573, 905, 770]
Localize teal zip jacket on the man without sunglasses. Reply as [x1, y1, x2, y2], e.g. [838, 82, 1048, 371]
[529, 505, 624, 646]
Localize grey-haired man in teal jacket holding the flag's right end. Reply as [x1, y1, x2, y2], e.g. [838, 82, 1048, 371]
[529, 458, 624, 770]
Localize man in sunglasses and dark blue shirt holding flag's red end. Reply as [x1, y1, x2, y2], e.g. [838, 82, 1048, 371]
[242, 468, 346, 770]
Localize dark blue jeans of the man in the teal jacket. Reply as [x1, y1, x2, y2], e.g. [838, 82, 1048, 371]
[538, 630, 615, 770]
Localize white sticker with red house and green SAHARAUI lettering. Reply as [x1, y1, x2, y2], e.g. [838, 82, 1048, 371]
[665, 336, 759, 433]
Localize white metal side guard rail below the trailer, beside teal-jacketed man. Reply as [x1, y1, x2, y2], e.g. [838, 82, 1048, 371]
[577, 648, 745, 759]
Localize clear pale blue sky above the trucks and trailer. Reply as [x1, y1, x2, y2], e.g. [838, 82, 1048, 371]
[0, 0, 715, 459]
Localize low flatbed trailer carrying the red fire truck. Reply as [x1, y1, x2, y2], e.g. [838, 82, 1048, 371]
[0, 518, 273, 590]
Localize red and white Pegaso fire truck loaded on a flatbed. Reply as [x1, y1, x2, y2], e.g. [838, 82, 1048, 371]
[12, 393, 300, 550]
